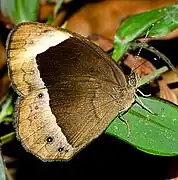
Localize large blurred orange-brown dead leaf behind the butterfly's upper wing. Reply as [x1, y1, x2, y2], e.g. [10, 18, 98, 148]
[67, 0, 178, 40]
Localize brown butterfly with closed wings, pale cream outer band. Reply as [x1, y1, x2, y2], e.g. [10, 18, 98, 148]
[7, 22, 137, 161]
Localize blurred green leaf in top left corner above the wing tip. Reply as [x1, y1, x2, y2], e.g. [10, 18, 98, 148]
[0, 0, 39, 24]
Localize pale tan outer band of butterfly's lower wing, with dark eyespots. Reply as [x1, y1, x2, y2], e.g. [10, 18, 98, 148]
[16, 89, 75, 160]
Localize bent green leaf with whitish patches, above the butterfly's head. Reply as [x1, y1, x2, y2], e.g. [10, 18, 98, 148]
[112, 5, 178, 61]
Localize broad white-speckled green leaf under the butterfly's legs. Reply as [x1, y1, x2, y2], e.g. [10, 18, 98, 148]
[105, 97, 178, 156]
